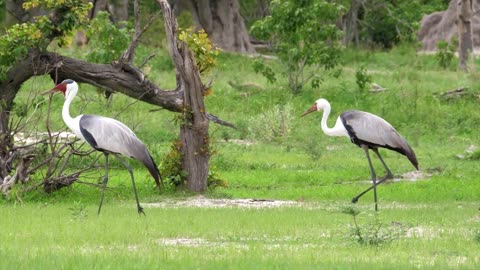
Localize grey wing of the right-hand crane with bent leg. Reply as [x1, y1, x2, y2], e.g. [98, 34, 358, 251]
[340, 111, 418, 168]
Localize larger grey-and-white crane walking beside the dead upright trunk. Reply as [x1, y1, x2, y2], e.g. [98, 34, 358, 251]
[45, 79, 162, 215]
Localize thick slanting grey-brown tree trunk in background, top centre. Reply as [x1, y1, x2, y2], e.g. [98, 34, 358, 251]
[171, 0, 255, 53]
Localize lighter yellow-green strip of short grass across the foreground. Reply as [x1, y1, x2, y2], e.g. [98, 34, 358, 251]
[0, 203, 480, 269]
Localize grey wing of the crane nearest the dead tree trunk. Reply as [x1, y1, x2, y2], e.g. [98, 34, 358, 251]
[80, 114, 161, 188]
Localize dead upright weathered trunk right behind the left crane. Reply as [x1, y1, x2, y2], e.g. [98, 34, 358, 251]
[157, 0, 210, 192]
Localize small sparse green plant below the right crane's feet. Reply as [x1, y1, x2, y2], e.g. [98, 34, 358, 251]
[342, 205, 408, 246]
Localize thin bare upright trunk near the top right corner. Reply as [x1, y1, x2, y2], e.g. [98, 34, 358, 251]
[457, 0, 473, 71]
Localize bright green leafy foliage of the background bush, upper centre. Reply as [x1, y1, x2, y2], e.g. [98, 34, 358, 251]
[251, 0, 343, 93]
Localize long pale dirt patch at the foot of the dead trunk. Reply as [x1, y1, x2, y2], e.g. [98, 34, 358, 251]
[144, 196, 301, 208]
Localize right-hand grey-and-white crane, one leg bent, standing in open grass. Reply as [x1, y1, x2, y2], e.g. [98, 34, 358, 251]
[302, 98, 418, 211]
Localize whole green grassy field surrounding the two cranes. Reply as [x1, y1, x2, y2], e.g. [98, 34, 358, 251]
[0, 46, 480, 269]
